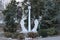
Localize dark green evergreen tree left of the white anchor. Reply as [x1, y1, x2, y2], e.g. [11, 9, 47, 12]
[3, 0, 17, 32]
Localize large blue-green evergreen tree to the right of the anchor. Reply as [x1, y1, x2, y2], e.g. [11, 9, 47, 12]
[42, 0, 57, 28]
